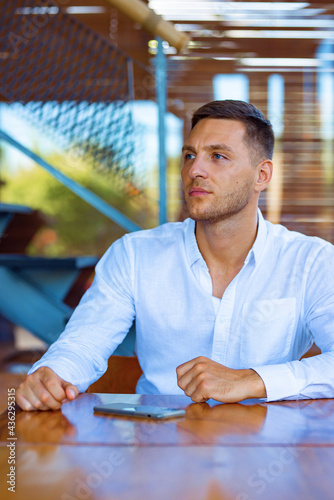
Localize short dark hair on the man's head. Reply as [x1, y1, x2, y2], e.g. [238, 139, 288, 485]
[191, 99, 275, 161]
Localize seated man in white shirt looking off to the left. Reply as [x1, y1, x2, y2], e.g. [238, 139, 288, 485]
[17, 100, 334, 410]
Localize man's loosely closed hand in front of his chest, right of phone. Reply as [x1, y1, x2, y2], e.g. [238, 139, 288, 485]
[176, 356, 267, 403]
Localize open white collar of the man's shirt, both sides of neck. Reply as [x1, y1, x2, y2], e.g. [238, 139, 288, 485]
[184, 208, 267, 266]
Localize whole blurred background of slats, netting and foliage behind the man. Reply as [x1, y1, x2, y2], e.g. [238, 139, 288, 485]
[0, 0, 334, 368]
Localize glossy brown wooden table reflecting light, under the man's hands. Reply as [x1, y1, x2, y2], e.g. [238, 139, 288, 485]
[0, 394, 334, 500]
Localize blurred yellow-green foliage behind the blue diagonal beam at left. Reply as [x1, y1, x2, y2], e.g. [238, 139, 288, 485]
[1, 150, 156, 256]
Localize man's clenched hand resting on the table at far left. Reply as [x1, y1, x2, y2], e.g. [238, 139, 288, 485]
[16, 366, 79, 411]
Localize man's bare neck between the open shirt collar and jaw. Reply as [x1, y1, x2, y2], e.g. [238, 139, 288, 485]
[196, 206, 257, 269]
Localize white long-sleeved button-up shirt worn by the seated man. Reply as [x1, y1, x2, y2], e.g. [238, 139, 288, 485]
[30, 211, 334, 401]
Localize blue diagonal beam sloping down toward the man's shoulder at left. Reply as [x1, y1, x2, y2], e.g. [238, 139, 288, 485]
[0, 130, 142, 232]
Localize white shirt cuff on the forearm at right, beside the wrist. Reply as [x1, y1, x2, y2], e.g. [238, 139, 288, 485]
[250, 364, 299, 401]
